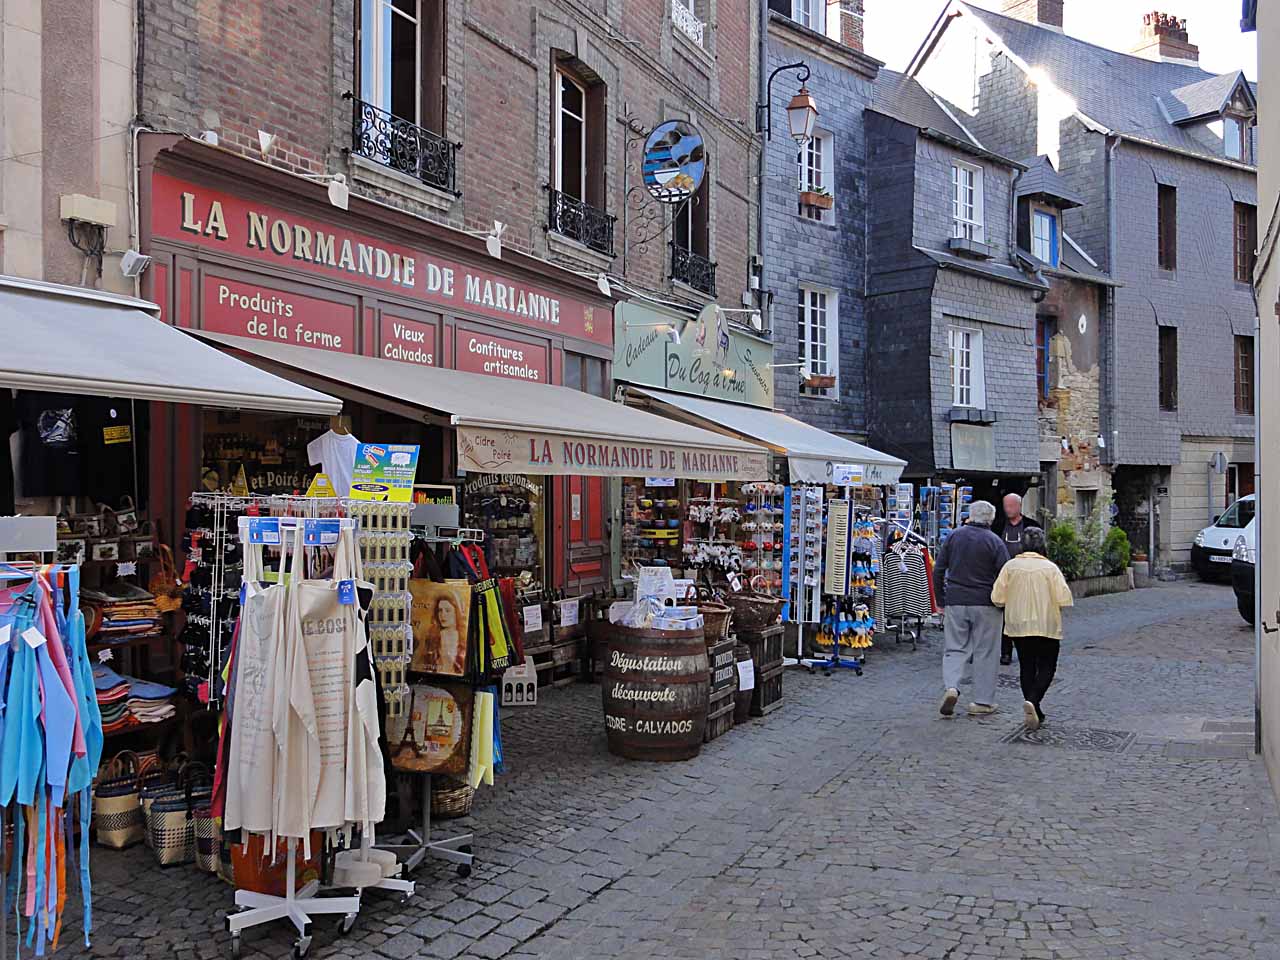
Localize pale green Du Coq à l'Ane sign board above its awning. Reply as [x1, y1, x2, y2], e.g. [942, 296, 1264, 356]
[613, 302, 773, 410]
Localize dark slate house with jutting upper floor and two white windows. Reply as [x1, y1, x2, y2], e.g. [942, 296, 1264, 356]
[864, 69, 1048, 499]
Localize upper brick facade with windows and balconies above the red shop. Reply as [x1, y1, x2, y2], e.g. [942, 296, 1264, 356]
[140, 0, 758, 307]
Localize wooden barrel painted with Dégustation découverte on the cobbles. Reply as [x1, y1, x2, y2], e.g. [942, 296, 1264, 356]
[602, 625, 710, 760]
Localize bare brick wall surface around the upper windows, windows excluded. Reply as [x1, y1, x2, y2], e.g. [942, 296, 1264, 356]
[140, 0, 756, 306]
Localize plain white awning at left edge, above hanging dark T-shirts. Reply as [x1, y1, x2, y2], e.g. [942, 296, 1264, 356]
[0, 276, 342, 416]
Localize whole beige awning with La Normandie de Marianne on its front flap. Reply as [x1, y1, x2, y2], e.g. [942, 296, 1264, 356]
[202, 333, 768, 481]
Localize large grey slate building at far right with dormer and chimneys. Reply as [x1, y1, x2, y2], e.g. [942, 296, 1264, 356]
[909, 0, 1257, 570]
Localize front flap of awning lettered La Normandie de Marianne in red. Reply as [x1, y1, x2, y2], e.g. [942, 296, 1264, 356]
[458, 424, 769, 481]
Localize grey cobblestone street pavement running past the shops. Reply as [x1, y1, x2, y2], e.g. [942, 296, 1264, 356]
[82, 584, 1280, 960]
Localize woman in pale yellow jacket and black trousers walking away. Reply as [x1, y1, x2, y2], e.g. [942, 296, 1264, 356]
[991, 529, 1073, 730]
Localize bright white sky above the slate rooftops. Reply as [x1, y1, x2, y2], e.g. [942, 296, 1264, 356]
[864, 0, 1258, 79]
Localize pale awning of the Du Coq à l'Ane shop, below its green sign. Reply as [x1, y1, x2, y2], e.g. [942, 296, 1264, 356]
[627, 387, 906, 485]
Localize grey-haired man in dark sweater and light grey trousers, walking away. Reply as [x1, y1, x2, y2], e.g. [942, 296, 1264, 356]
[933, 500, 1009, 717]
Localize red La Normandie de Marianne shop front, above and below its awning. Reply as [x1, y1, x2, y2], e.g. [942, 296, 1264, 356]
[141, 134, 613, 590]
